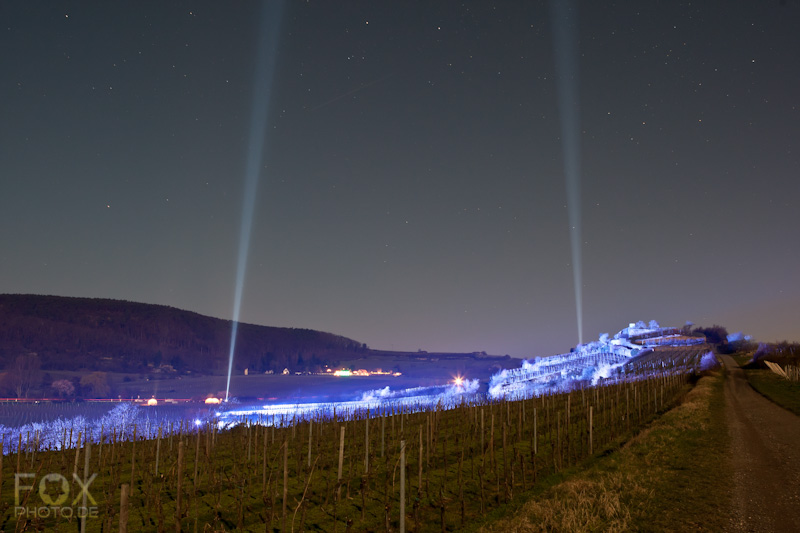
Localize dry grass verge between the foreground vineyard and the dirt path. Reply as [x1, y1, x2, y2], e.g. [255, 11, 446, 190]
[480, 372, 732, 533]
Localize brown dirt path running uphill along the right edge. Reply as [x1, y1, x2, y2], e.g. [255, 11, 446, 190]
[722, 355, 800, 531]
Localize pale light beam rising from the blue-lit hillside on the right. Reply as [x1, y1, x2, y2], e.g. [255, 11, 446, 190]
[550, 0, 583, 344]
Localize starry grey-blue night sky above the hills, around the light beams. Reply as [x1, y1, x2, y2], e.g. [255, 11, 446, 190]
[0, 0, 800, 357]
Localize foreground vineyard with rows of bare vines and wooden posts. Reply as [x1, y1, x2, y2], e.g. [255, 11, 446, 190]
[0, 371, 689, 531]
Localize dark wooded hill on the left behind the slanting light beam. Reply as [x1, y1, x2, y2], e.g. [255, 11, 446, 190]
[0, 294, 367, 374]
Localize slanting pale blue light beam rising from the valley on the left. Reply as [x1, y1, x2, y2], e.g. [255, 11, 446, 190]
[225, 0, 283, 402]
